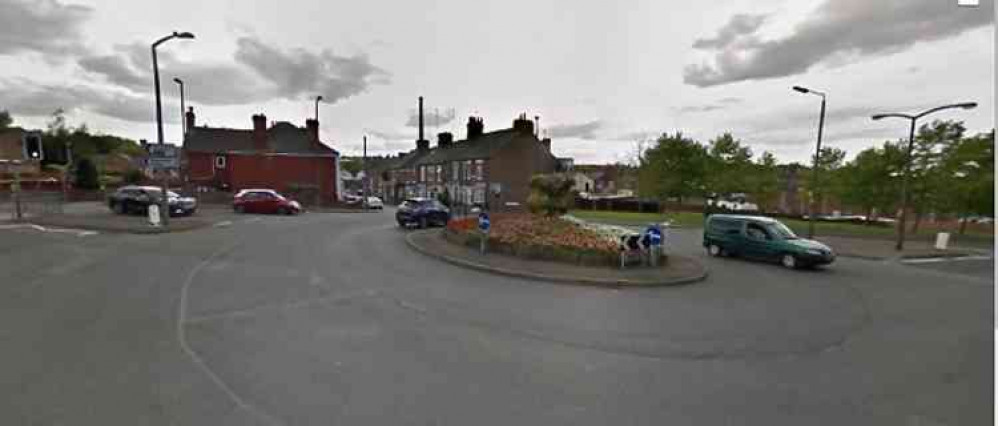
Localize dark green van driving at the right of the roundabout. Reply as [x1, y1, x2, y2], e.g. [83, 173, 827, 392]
[703, 214, 835, 269]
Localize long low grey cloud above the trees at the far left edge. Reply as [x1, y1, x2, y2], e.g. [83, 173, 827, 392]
[0, 80, 179, 123]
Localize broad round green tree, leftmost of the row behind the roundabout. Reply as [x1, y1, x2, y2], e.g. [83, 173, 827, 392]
[638, 132, 707, 203]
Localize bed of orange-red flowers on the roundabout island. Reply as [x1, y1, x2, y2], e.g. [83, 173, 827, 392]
[444, 214, 618, 266]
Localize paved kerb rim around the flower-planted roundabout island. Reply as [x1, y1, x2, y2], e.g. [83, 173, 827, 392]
[405, 230, 707, 288]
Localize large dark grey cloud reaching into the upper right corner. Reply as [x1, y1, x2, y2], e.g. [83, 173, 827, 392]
[683, 0, 994, 87]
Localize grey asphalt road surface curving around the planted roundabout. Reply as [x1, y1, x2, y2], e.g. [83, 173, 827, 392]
[0, 211, 994, 425]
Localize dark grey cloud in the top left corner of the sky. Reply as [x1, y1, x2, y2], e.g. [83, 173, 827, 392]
[0, 0, 93, 54]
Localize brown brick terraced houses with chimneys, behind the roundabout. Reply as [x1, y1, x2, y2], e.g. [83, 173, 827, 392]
[372, 115, 559, 211]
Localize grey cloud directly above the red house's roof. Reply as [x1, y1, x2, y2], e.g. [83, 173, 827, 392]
[235, 37, 389, 103]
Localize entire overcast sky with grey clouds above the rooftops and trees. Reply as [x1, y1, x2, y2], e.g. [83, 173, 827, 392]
[0, 0, 995, 163]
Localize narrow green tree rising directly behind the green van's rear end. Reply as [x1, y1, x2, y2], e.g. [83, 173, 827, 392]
[705, 133, 752, 194]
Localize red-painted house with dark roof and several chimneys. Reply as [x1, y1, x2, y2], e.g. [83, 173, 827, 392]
[183, 108, 341, 204]
